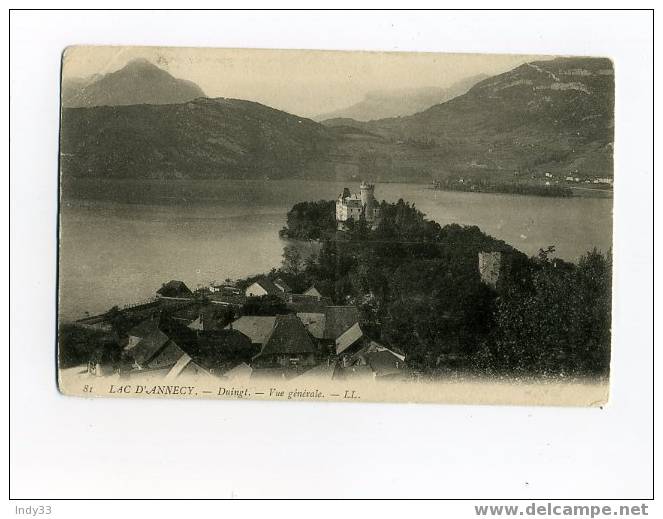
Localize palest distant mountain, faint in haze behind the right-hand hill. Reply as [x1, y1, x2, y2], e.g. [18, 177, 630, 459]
[314, 74, 488, 121]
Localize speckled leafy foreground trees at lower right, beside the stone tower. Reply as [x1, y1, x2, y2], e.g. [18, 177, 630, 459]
[493, 249, 610, 376]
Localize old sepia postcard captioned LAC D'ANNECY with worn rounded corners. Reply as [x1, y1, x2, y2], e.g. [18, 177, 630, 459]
[58, 46, 614, 406]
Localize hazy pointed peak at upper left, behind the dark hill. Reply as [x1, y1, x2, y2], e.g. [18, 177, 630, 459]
[62, 59, 205, 108]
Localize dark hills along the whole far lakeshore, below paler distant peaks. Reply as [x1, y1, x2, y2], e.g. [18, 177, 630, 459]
[61, 58, 614, 182]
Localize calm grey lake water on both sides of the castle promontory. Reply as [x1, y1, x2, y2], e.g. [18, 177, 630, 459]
[60, 180, 612, 320]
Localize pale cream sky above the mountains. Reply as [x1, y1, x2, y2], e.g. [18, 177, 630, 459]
[62, 46, 550, 117]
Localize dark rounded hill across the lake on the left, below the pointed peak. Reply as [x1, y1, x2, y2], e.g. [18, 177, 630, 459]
[61, 98, 334, 178]
